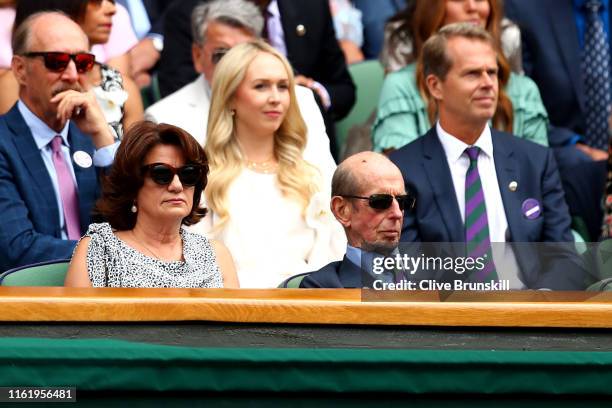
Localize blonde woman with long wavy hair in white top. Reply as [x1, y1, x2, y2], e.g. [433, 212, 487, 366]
[204, 41, 346, 288]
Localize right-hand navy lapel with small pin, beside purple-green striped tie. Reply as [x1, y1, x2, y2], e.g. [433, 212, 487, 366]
[491, 129, 526, 242]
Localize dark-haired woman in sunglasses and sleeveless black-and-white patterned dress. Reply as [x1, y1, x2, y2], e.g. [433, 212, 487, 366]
[65, 122, 238, 288]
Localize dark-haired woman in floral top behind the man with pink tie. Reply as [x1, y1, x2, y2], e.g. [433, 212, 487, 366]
[0, 0, 143, 139]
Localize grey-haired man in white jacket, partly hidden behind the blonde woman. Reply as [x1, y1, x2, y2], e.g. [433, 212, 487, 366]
[145, 0, 336, 182]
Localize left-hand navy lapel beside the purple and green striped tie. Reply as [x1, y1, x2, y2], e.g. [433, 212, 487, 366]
[423, 128, 464, 242]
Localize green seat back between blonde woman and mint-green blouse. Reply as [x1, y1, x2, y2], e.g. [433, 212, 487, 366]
[336, 60, 385, 157]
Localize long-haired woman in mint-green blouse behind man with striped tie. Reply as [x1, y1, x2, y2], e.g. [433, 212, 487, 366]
[372, 0, 548, 151]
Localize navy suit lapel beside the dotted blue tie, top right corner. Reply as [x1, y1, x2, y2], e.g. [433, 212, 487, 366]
[546, 0, 585, 111]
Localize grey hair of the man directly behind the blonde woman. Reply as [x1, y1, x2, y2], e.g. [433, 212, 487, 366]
[191, 0, 264, 45]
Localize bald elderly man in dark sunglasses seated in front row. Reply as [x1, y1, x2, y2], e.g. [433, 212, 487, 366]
[300, 152, 414, 288]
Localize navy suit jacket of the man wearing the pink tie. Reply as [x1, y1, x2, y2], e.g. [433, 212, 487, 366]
[0, 105, 99, 271]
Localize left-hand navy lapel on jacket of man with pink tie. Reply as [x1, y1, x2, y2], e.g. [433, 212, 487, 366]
[6, 105, 58, 210]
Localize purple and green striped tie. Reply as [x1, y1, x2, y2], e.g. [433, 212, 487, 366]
[465, 146, 497, 282]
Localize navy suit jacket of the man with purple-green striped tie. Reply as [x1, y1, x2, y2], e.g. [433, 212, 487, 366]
[390, 127, 584, 290]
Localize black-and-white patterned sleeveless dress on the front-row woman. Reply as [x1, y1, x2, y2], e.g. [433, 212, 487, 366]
[85, 223, 223, 288]
